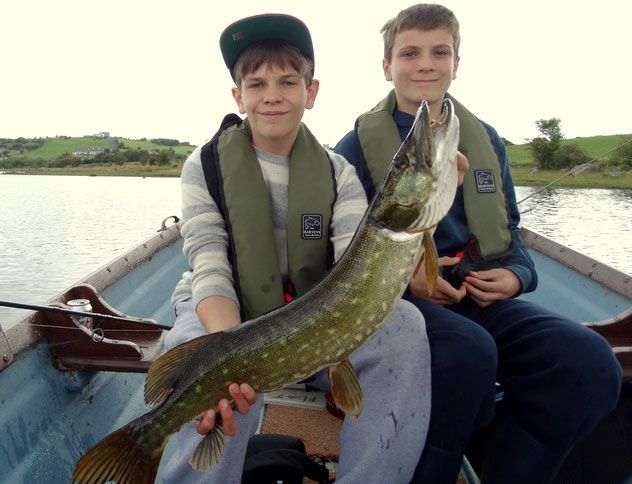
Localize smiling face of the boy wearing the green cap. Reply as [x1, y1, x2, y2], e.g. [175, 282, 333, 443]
[233, 62, 319, 156]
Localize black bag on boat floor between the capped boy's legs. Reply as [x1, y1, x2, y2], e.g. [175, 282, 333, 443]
[241, 434, 329, 484]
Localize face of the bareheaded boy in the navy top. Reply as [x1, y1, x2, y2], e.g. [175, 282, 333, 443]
[382, 28, 459, 119]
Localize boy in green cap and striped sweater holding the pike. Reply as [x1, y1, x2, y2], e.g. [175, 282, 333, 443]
[163, 15, 430, 484]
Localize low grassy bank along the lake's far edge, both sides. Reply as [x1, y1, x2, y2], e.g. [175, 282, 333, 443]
[0, 165, 632, 189]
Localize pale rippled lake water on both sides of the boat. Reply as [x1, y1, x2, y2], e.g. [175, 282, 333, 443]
[0, 175, 632, 327]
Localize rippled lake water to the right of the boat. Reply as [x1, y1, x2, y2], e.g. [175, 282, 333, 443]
[516, 187, 632, 274]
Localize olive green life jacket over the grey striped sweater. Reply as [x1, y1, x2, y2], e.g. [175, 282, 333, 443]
[202, 114, 336, 319]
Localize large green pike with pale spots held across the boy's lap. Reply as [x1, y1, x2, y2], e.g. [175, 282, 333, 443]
[72, 100, 459, 484]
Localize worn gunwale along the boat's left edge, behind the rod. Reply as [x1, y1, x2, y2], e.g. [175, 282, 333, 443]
[0, 223, 180, 371]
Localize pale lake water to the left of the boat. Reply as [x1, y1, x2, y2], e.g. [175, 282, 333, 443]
[0, 175, 182, 327]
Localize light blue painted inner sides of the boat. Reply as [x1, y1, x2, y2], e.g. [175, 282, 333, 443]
[0, 227, 632, 484]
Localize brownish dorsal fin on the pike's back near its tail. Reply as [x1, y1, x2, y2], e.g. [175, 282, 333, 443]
[145, 333, 212, 404]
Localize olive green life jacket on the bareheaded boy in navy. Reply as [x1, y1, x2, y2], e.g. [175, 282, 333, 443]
[356, 90, 513, 259]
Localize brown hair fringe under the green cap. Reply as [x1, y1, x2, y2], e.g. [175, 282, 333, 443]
[233, 40, 314, 88]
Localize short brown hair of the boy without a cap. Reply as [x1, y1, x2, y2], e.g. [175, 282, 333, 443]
[380, 3, 461, 62]
